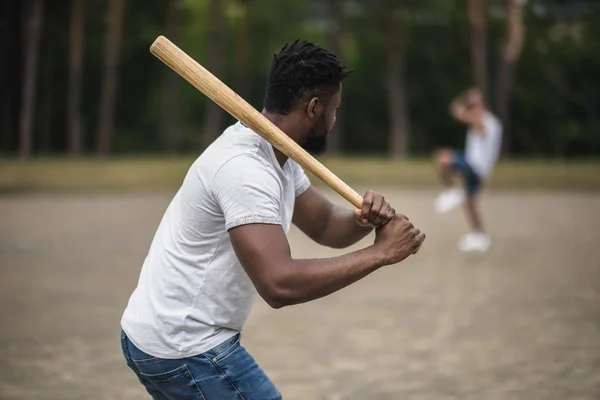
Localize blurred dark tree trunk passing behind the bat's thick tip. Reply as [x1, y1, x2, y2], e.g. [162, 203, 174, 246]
[161, 0, 183, 154]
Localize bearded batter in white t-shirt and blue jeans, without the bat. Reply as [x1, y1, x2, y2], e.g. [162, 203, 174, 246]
[121, 41, 425, 400]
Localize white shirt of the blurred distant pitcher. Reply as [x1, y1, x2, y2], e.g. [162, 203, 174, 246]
[465, 111, 502, 179]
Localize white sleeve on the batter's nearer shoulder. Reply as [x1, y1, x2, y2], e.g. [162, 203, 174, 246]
[213, 155, 282, 230]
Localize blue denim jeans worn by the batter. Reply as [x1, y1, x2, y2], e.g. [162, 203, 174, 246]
[121, 331, 282, 400]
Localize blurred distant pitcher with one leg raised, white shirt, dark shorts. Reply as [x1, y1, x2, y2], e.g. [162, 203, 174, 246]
[435, 89, 502, 252]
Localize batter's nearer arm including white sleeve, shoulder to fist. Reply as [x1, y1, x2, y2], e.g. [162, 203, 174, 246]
[212, 155, 425, 308]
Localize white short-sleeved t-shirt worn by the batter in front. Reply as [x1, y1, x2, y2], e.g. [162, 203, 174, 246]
[121, 122, 310, 358]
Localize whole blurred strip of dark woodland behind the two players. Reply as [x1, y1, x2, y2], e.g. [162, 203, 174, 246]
[0, 0, 600, 158]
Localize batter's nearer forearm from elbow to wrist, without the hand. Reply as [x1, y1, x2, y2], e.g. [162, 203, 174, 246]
[269, 246, 387, 308]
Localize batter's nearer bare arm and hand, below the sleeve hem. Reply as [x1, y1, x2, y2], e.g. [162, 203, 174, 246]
[229, 216, 425, 308]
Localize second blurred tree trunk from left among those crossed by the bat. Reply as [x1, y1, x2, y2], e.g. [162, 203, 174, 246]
[202, 0, 225, 147]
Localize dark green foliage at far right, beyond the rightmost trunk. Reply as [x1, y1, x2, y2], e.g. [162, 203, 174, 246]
[507, 8, 600, 156]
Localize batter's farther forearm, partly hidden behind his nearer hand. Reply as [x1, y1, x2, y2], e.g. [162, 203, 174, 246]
[320, 205, 373, 249]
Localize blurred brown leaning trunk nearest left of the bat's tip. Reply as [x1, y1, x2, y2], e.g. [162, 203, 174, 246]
[98, 0, 125, 156]
